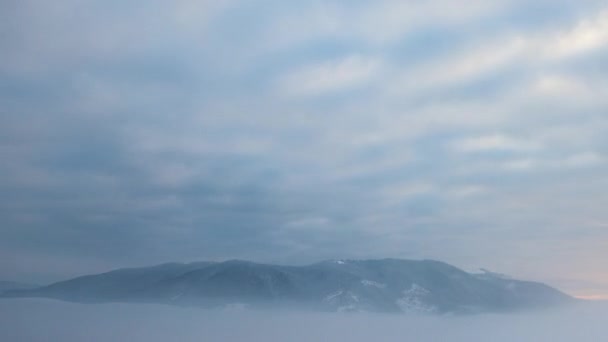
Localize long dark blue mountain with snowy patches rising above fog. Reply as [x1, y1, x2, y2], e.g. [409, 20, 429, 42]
[2, 259, 574, 313]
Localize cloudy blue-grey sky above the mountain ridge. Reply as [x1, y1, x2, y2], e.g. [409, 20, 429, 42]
[0, 0, 608, 298]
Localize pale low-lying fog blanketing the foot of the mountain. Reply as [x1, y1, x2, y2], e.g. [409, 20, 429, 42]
[0, 299, 608, 342]
